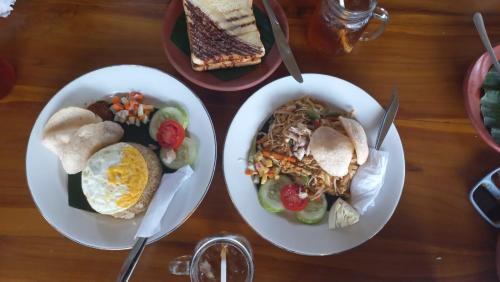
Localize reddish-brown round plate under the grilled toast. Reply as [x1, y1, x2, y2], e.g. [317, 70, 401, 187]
[163, 0, 288, 91]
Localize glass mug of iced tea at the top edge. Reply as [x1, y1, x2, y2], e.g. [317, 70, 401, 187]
[307, 0, 389, 54]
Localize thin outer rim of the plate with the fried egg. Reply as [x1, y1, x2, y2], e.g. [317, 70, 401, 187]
[25, 64, 217, 251]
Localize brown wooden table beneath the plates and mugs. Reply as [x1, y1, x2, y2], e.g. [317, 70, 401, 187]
[0, 0, 500, 281]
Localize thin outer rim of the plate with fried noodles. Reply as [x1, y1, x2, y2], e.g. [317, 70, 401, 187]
[221, 73, 406, 257]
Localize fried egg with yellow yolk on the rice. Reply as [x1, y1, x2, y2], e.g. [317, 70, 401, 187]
[82, 143, 148, 215]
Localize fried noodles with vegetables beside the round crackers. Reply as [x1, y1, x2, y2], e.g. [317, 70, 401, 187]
[256, 97, 358, 199]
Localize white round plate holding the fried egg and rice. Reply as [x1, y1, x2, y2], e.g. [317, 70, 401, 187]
[26, 65, 217, 250]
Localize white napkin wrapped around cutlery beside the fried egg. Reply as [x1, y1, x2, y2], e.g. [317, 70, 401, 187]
[135, 166, 193, 238]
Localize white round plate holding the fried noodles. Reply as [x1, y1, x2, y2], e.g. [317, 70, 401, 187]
[223, 74, 405, 255]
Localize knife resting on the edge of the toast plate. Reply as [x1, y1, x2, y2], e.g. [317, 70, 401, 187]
[262, 0, 304, 83]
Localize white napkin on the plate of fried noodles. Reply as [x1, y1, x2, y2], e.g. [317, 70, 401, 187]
[350, 149, 389, 214]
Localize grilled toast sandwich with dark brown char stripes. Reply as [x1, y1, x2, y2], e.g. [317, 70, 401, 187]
[183, 0, 265, 71]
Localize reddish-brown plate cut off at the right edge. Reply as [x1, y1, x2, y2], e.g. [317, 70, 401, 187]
[464, 45, 500, 153]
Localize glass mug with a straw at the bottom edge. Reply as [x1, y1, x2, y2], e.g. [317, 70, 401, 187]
[169, 234, 254, 282]
